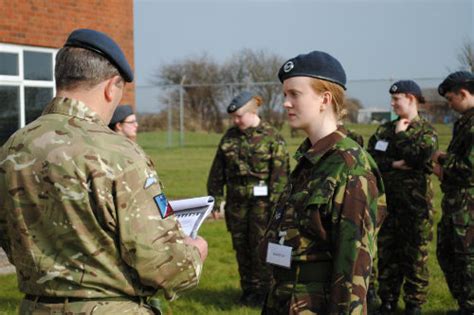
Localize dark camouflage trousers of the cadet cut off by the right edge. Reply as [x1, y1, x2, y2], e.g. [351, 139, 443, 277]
[436, 189, 474, 311]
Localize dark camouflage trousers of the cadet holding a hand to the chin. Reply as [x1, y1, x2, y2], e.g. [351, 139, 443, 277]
[378, 182, 433, 305]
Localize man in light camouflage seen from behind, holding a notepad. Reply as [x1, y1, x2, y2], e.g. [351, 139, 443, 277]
[0, 29, 207, 314]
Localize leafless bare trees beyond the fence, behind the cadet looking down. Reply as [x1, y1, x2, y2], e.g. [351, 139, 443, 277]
[152, 49, 284, 132]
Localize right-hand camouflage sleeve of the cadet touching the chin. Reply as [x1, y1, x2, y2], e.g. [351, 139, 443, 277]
[395, 129, 438, 170]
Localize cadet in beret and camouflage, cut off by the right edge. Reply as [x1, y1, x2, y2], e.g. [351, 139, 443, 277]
[433, 71, 474, 315]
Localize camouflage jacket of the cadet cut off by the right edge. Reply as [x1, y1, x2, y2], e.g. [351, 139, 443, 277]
[440, 108, 474, 192]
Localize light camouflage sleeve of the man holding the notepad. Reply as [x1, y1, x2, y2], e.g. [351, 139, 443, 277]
[114, 162, 202, 299]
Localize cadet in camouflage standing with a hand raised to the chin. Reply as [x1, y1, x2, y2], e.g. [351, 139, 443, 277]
[367, 80, 438, 314]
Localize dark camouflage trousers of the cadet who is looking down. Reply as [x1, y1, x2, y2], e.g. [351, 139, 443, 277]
[225, 197, 272, 294]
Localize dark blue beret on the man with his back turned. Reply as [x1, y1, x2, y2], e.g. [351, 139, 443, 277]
[64, 29, 133, 82]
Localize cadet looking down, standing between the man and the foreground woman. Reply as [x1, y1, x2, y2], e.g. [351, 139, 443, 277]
[207, 91, 290, 306]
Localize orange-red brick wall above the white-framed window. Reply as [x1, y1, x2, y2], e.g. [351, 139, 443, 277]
[0, 0, 135, 105]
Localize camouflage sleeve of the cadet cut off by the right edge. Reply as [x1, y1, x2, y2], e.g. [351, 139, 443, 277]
[440, 127, 474, 187]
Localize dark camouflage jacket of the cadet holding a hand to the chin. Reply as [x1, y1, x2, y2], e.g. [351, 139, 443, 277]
[367, 116, 438, 181]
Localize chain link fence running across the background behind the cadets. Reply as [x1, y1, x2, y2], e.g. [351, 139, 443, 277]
[135, 77, 452, 146]
